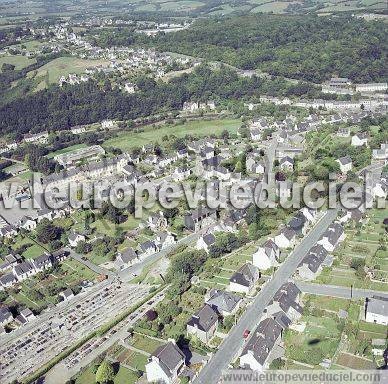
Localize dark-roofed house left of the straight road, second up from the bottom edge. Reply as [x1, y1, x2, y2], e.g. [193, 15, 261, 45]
[186, 304, 218, 344]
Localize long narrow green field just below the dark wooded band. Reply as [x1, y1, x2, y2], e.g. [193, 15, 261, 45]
[104, 119, 241, 152]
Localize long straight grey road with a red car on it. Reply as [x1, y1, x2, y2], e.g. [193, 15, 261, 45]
[194, 210, 337, 384]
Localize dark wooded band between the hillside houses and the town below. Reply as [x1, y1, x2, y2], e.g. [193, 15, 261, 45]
[0, 65, 317, 137]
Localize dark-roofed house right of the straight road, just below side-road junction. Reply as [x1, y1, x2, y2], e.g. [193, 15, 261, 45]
[267, 282, 303, 321]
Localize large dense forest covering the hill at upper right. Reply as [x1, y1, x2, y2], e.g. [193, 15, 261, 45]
[98, 15, 388, 83]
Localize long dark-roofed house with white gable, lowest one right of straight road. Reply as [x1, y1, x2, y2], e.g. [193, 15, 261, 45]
[240, 318, 284, 372]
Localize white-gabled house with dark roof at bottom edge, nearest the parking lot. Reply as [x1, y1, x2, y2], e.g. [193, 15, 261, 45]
[145, 341, 185, 384]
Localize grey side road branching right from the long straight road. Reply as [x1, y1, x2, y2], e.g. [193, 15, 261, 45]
[295, 281, 388, 299]
